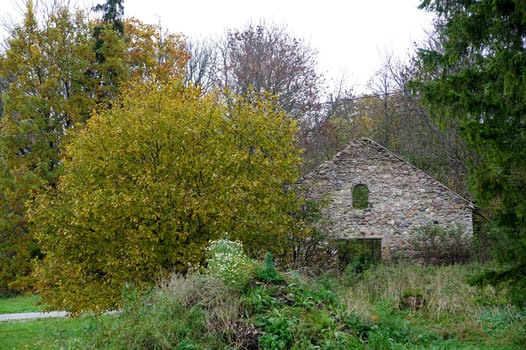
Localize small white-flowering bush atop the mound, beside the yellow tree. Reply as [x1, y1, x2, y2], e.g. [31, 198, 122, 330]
[206, 237, 255, 288]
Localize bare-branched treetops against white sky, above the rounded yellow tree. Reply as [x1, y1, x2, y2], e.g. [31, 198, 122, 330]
[188, 21, 322, 122]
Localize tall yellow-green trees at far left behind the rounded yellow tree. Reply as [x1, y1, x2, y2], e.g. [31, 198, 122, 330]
[0, 0, 192, 294]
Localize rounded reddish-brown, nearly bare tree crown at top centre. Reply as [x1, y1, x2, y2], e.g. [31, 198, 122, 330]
[222, 24, 320, 119]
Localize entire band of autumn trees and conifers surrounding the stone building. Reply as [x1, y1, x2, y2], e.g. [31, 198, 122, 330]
[0, 0, 526, 311]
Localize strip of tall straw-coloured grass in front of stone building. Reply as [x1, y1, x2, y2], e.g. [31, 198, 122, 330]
[346, 263, 506, 319]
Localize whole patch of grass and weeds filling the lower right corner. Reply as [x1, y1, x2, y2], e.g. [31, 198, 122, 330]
[340, 264, 526, 349]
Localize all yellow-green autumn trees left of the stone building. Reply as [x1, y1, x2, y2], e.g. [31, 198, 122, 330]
[0, 1, 308, 312]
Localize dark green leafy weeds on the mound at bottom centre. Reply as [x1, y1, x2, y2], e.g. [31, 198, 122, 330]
[242, 275, 359, 349]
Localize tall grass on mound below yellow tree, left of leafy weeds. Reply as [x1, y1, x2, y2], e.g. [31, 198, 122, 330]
[73, 275, 244, 349]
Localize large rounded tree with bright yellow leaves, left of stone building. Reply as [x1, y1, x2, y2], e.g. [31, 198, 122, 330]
[29, 82, 302, 313]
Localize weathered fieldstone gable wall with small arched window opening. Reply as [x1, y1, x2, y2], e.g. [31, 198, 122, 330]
[301, 139, 473, 259]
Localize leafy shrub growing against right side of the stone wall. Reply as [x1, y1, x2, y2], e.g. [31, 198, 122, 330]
[409, 224, 471, 265]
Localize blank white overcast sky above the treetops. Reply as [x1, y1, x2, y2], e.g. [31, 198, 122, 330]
[0, 0, 432, 91]
